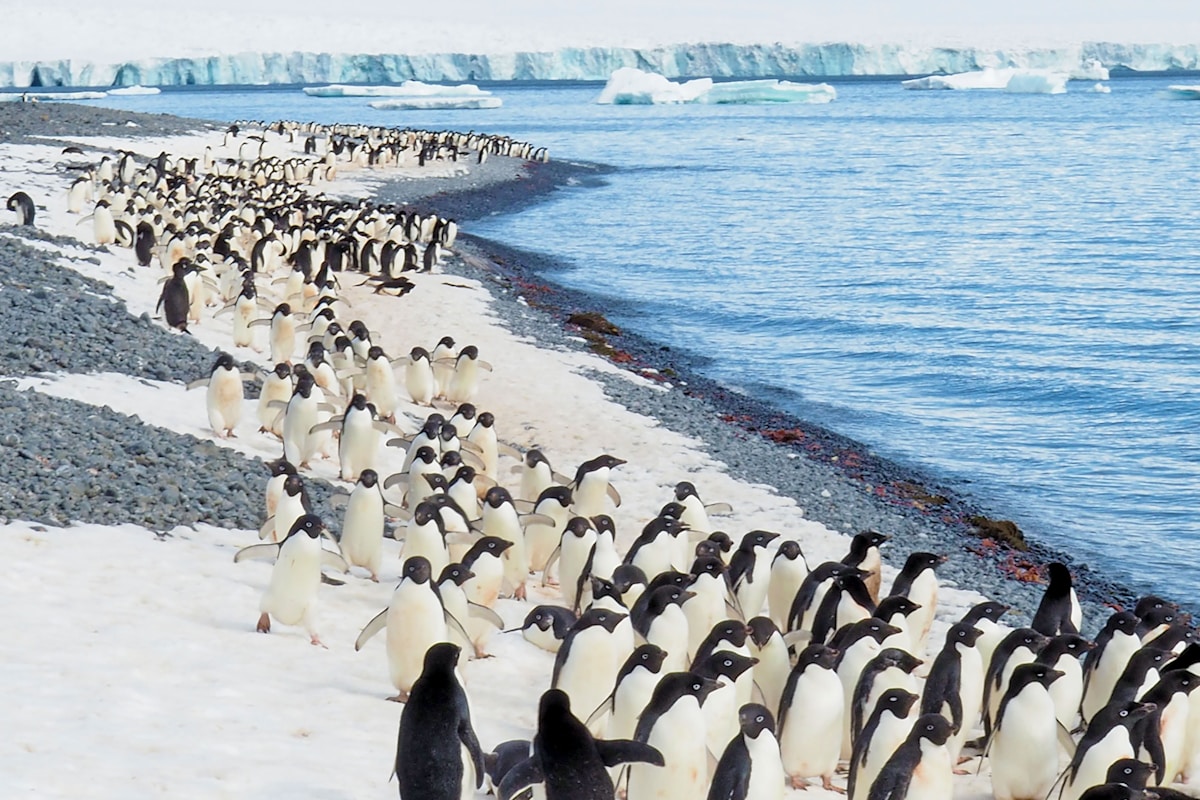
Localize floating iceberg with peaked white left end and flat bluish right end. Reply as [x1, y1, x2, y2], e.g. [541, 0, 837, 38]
[596, 67, 838, 106]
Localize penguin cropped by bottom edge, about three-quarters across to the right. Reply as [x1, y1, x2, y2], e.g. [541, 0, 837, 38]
[866, 714, 954, 800]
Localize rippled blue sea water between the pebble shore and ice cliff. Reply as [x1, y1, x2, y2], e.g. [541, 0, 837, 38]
[91, 78, 1200, 599]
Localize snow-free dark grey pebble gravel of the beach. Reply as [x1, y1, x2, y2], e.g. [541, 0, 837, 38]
[0, 103, 1161, 634]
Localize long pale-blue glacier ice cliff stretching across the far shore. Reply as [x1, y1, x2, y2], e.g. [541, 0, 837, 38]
[0, 42, 1200, 89]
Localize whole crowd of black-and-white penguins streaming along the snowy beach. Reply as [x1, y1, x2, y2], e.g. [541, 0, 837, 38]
[37, 122, 1200, 800]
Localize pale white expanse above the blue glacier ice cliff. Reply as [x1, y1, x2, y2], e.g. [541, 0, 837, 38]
[7, 0, 1200, 61]
